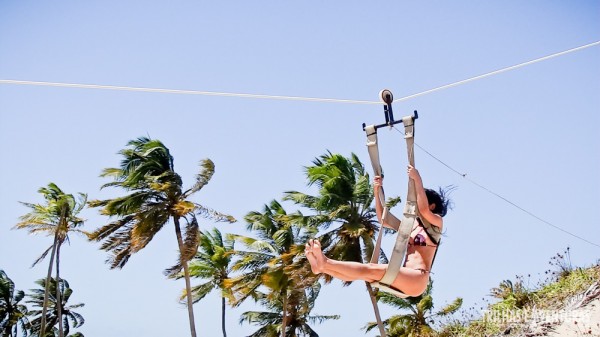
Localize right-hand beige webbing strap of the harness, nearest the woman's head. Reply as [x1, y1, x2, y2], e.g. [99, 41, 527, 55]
[378, 116, 418, 285]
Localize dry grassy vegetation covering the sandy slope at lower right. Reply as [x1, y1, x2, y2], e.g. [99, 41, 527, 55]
[439, 248, 600, 337]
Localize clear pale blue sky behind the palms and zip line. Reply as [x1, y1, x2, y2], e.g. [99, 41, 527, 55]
[0, 0, 600, 336]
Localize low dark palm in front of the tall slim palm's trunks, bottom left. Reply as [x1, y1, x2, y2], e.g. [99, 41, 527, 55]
[27, 278, 85, 337]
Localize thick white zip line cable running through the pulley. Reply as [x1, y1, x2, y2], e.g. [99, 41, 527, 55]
[0, 41, 600, 105]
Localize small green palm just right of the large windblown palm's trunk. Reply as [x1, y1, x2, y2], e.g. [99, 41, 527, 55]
[183, 228, 234, 337]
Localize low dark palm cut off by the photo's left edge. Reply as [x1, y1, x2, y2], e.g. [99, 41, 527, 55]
[0, 270, 29, 337]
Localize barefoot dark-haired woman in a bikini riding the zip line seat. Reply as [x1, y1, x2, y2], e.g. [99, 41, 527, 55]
[305, 165, 449, 296]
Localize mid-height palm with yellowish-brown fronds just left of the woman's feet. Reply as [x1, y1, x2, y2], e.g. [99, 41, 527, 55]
[225, 200, 317, 336]
